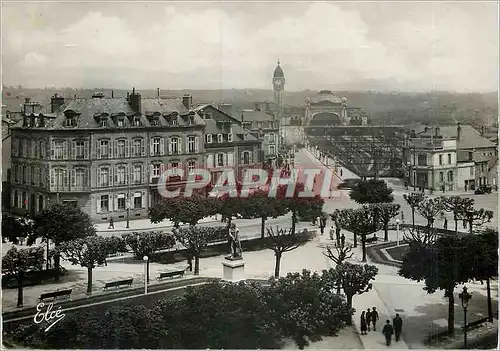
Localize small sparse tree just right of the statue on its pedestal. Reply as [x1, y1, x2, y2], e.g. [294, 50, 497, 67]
[266, 226, 311, 278]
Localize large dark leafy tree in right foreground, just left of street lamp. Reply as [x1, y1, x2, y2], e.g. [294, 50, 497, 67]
[399, 236, 469, 335]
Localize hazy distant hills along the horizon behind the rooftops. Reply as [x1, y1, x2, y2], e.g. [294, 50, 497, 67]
[2, 87, 498, 124]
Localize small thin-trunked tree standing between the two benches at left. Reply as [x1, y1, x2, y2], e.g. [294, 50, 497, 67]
[58, 236, 110, 295]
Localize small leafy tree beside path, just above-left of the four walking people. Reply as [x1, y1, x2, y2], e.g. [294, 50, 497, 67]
[323, 262, 378, 318]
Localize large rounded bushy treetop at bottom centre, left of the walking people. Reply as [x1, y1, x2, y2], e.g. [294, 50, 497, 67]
[264, 270, 354, 349]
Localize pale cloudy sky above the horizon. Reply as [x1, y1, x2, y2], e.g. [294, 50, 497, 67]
[2, 1, 499, 92]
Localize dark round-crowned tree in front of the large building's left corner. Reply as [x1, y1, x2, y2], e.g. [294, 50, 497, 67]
[28, 204, 96, 281]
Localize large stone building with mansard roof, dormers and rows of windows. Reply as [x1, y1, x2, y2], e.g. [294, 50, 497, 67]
[10, 90, 258, 222]
